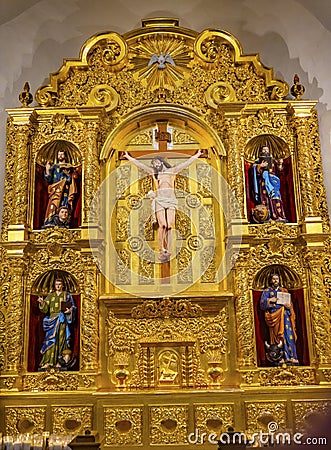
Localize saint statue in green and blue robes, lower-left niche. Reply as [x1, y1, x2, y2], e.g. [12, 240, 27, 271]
[38, 278, 77, 370]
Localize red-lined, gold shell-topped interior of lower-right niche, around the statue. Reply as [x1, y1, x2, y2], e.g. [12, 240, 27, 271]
[252, 264, 309, 367]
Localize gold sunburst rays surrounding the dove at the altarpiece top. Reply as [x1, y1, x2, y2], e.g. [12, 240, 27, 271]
[129, 35, 193, 90]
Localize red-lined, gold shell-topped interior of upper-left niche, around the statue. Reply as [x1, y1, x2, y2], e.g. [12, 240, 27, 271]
[33, 139, 82, 230]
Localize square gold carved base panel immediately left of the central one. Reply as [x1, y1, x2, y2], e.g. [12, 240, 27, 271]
[104, 407, 143, 445]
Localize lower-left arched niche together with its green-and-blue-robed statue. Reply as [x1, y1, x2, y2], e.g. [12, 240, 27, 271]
[28, 270, 80, 372]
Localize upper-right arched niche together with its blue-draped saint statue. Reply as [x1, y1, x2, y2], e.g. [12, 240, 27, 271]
[245, 134, 296, 223]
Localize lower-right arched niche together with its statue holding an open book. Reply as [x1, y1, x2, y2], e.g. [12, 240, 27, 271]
[253, 264, 309, 367]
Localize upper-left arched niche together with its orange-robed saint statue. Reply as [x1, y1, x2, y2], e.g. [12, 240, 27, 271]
[33, 139, 81, 229]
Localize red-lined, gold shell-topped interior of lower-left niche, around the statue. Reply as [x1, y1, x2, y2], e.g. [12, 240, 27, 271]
[27, 269, 81, 372]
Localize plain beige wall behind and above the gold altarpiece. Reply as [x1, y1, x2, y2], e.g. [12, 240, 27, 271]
[0, 0, 331, 218]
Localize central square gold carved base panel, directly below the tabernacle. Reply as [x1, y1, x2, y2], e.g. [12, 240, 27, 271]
[150, 405, 188, 445]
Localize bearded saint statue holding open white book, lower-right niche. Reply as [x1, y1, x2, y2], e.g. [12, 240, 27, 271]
[260, 274, 299, 365]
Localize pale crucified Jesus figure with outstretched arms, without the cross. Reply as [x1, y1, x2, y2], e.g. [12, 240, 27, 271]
[123, 150, 203, 262]
